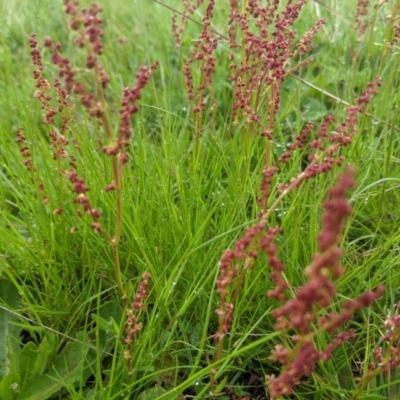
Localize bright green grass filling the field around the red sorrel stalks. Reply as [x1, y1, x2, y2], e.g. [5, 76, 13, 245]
[0, 0, 400, 400]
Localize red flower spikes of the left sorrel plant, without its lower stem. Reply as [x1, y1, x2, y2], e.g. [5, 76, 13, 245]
[27, 0, 157, 238]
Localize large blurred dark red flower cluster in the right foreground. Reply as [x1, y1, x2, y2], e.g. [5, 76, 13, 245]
[265, 169, 383, 398]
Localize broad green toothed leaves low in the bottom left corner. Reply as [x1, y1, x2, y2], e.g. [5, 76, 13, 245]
[0, 292, 115, 400]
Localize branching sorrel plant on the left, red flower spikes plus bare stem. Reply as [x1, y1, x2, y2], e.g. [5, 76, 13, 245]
[22, 0, 157, 301]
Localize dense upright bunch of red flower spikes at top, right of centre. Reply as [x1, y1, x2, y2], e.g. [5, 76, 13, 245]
[228, 0, 324, 136]
